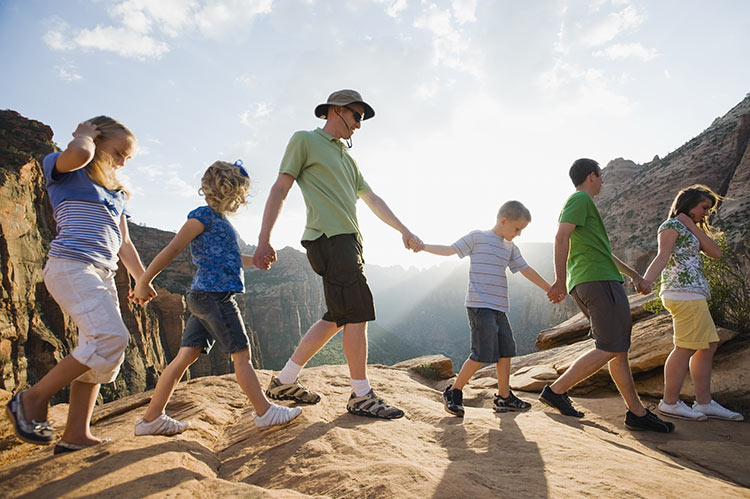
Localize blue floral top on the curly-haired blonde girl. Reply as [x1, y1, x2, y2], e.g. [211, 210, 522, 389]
[188, 206, 245, 293]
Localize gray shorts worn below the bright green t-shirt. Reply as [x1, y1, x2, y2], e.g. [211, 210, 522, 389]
[570, 281, 633, 353]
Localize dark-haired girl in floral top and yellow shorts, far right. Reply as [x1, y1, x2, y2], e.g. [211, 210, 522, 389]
[644, 185, 744, 421]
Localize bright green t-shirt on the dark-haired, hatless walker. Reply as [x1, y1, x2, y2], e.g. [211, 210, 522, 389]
[558, 191, 623, 292]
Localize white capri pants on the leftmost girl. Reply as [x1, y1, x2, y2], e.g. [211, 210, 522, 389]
[43, 257, 130, 383]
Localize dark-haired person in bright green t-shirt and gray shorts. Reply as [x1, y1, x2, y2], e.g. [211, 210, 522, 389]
[539, 158, 674, 433]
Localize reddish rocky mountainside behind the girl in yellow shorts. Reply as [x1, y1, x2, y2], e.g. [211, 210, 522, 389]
[594, 95, 750, 271]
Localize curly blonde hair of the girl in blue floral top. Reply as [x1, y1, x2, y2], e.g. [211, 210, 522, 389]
[198, 161, 250, 213]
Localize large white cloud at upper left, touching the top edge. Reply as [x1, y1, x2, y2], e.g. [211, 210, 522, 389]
[42, 0, 272, 60]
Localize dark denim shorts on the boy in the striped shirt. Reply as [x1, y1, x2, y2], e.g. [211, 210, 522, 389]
[466, 307, 516, 364]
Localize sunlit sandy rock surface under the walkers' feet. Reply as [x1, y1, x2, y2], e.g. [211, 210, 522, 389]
[0, 366, 750, 498]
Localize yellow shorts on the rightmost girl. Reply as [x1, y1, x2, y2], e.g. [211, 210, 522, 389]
[662, 298, 719, 350]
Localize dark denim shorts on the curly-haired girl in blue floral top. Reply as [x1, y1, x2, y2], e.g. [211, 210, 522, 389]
[180, 290, 250, 353]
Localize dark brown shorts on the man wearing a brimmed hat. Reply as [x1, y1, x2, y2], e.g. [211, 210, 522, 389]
[302, 234, 375, 326]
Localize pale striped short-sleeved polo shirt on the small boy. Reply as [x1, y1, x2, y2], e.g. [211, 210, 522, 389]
[452, 230, 529, 312]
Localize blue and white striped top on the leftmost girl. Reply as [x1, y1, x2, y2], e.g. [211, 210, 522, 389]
[42, 152, 126, 270]
